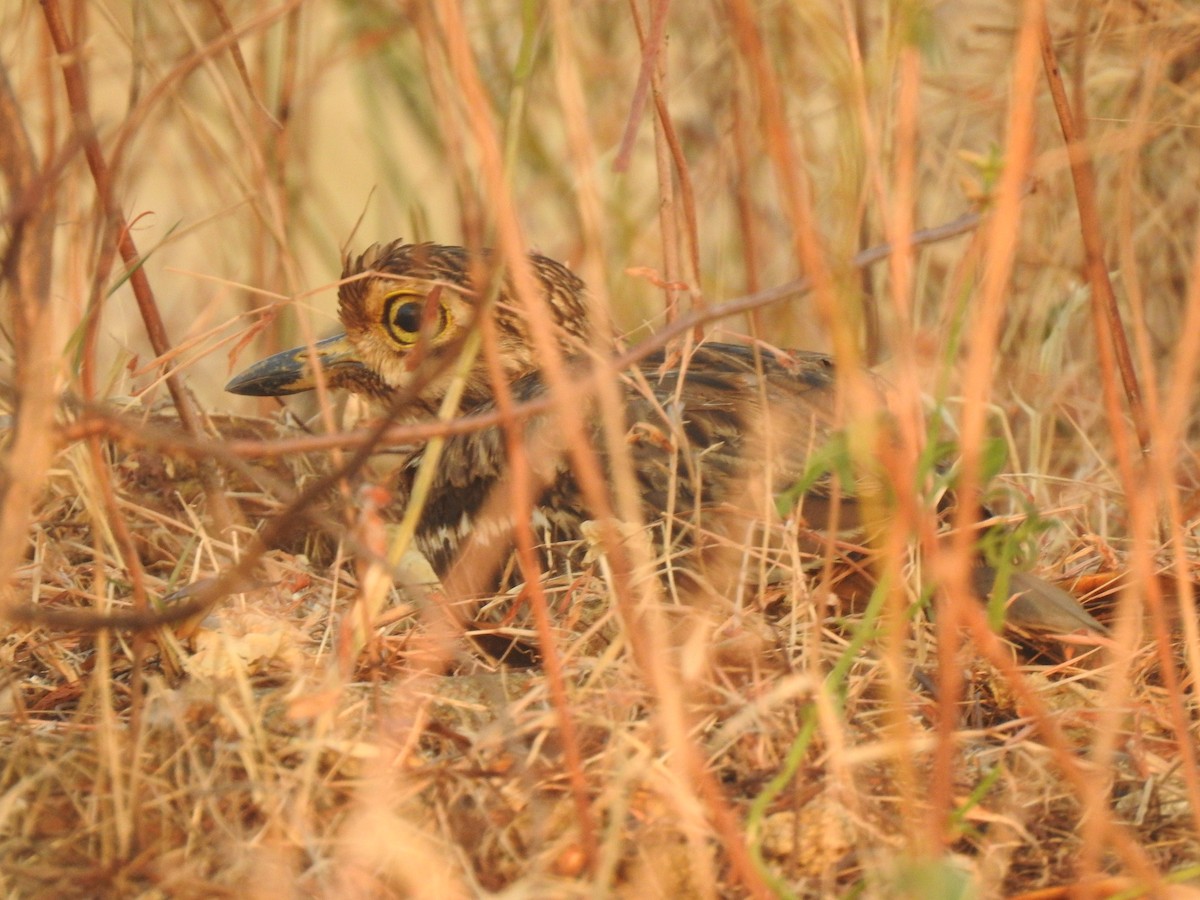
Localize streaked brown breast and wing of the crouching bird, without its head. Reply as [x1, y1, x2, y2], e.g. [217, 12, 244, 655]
[404, 343, 849, 574]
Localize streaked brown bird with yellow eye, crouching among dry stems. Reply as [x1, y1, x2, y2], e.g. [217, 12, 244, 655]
[226, 240, 1105, 634]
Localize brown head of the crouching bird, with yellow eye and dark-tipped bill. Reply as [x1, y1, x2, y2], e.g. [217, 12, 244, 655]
[226, 241, 587, 409]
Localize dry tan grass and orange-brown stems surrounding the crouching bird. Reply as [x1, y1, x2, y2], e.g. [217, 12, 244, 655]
[0, 0, 1200, 898]
